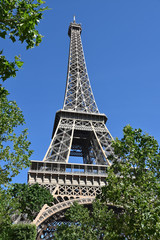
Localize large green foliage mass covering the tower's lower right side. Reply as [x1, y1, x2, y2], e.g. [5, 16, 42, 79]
[55, 125, 160, 240]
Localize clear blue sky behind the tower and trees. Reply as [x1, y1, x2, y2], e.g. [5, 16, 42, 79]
[0, 0, 160, 182]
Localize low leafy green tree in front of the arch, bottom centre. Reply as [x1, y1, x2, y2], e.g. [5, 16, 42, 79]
[54, 200, 118, 240]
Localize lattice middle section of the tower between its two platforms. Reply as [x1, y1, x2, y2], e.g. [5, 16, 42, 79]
[43, 118, 113, 165]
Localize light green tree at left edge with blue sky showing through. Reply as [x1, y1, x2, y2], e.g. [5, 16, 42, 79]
[0, 87, 32, 185]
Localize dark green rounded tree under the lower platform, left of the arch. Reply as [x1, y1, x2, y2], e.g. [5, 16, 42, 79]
[9, 183, 53, 221]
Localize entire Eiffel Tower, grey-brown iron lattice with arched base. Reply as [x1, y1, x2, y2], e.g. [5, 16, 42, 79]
[28, 17, 113, 239]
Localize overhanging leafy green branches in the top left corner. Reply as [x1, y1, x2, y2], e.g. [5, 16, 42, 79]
[0, 0, 47, 81]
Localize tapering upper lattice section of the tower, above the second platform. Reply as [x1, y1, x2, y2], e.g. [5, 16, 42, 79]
[63, 20, 99, 113]
